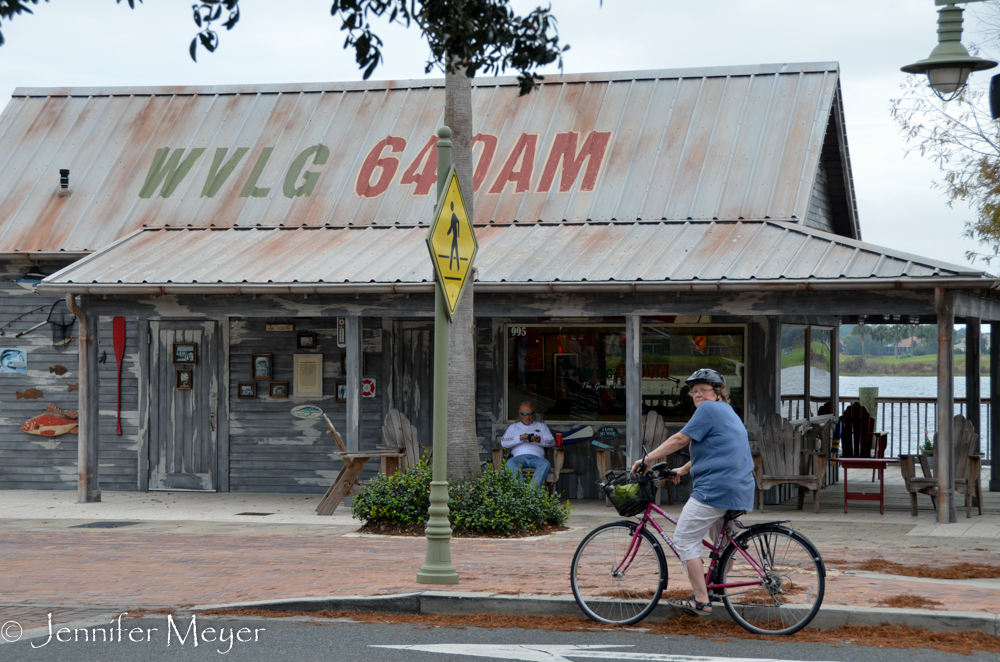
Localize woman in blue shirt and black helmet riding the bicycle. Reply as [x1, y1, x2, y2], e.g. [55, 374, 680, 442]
[632, 368, 754, 616]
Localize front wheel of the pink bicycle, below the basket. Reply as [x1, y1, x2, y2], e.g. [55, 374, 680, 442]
[570, 522, 667, 625]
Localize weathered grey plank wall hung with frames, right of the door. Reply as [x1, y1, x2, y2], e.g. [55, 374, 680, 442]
[229, 318, 384, 494]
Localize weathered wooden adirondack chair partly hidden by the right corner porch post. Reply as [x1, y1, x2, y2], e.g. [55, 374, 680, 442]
[899, 415, 983, 518]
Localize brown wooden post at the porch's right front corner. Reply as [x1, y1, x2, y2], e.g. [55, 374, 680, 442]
[934, 287, 958, 524]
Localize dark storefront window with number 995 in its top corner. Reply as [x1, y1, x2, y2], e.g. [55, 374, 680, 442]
[507, 325, 625, 421]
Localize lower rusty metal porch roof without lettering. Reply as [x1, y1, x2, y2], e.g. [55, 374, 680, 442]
[41, 221, 996, 293]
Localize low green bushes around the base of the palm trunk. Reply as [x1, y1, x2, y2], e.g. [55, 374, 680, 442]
[351, 460, 569, 535]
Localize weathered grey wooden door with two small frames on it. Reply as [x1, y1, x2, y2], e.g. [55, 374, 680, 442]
[149, 320, 221, 492]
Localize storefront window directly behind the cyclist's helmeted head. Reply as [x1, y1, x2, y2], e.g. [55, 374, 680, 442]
[642, 326, 745, 422]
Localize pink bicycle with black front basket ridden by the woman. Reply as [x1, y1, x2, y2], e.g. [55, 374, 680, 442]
[570, 462, 826, 634]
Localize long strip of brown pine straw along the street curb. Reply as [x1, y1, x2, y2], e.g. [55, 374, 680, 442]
[200, 609, 1000, 655]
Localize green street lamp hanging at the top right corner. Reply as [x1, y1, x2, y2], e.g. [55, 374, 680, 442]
[902, 0, 997, 102]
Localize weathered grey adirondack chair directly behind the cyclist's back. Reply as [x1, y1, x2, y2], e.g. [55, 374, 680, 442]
[754, 414, 829, 513]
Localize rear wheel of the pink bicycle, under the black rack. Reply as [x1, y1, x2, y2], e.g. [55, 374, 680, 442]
[718, 526, 826, 634]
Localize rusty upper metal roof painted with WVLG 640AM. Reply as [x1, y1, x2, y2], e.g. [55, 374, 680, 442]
[0, 63, 839, 255]
